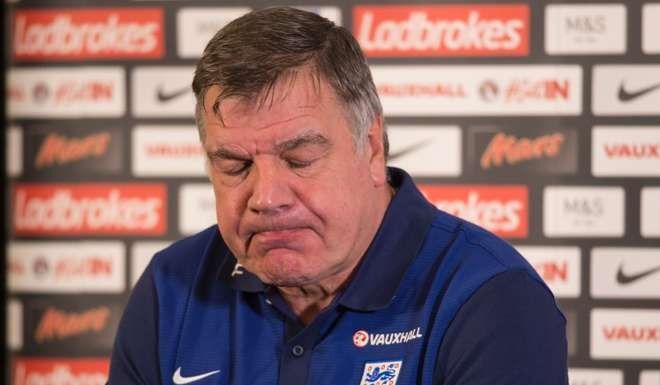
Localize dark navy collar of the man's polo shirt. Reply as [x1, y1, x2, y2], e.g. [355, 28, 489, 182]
[218, 167, 437, 311]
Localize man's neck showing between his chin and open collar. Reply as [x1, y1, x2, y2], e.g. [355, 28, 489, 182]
[277, 184, 394, 325]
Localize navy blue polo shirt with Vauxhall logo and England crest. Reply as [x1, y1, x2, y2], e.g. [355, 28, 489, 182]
[109, 169, 568, 385]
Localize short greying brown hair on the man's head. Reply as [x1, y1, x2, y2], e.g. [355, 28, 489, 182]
[192, 7, 389, 156]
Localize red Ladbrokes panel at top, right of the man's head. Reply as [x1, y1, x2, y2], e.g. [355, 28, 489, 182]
[354, 5, 529, 56]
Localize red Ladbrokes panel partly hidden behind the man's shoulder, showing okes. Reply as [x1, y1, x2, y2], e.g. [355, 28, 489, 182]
[420, 185, 528, 238]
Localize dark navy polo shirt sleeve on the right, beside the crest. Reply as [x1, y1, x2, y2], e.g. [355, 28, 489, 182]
[434, 270, 568, 385]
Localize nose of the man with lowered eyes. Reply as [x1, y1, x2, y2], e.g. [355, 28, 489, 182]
[248, 162, 293, 214]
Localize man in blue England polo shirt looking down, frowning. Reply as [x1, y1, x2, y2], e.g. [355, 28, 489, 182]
[109, 8, 567, 385]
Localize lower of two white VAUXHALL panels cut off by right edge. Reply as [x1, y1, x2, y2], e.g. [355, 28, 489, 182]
[591, 309, 660, 359]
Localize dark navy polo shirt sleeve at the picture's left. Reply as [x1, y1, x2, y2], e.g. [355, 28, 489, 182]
[107, 260, 161, 385]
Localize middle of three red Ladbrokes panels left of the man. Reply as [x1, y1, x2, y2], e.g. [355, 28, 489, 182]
[13, 184, 167, 235]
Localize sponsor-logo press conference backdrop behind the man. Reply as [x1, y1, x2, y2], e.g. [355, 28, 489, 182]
[4, 0, 660, 385]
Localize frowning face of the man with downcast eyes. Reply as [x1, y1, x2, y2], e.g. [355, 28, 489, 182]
[204, 71, 389, 286]
